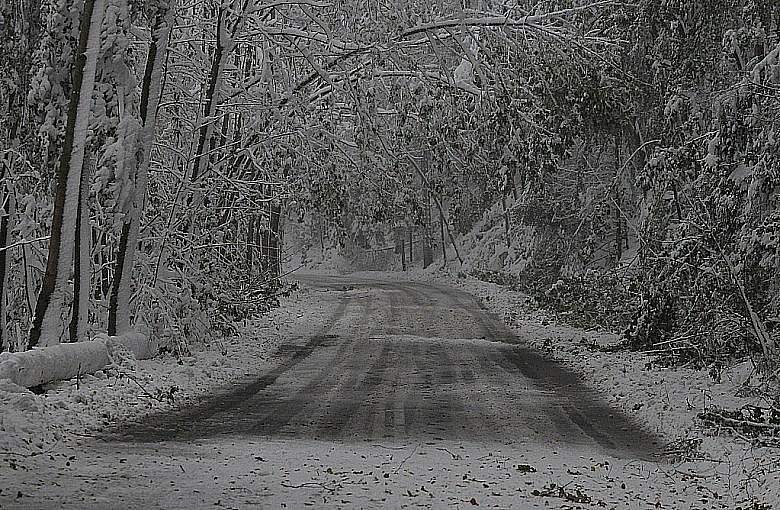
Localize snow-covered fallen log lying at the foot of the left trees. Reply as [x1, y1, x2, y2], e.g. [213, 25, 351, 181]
[0, 333, 159, 388]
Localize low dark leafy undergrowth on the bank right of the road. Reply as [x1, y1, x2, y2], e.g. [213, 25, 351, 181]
[471, 268, 771, 370]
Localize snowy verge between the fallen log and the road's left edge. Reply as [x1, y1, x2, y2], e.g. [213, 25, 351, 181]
[0, 284, 332, 458]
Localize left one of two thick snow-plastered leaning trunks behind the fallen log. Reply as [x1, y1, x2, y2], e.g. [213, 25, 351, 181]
[29, 0, 106, 347]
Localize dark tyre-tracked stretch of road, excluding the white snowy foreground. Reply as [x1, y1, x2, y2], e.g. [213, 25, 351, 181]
[116, 275, 655, 457]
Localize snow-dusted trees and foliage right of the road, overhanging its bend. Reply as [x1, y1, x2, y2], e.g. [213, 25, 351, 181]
[298, 0, 780, 370]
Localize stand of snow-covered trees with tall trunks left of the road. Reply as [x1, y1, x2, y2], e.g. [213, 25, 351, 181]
[0, 0, 289, 353]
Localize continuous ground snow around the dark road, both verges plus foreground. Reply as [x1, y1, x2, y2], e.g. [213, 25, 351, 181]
[0, 271, 780, 509]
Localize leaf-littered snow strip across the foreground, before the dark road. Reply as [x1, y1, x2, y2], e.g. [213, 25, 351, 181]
[0, 424, 772, 509]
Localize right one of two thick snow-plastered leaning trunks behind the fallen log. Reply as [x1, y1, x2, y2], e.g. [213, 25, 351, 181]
[108, 0, 178, 335]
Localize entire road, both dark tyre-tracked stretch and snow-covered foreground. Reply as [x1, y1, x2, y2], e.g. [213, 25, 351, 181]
[0, 275, 684, 509]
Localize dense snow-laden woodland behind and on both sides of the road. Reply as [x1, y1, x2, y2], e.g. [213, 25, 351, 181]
[0, 0, 780, 373]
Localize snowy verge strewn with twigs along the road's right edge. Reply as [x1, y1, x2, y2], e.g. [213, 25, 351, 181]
[407, 268, 780, 508]
